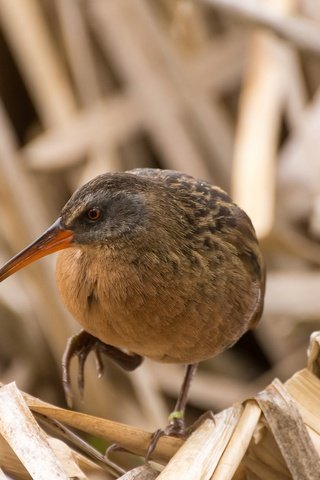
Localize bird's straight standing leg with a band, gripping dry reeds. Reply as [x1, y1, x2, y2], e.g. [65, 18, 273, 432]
[146, 363, 198, 461]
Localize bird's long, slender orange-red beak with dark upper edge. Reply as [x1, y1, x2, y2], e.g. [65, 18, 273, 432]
[0, 218, 73, 282]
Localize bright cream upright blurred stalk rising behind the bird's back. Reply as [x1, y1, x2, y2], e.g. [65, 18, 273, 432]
[233, 0, 295, 237]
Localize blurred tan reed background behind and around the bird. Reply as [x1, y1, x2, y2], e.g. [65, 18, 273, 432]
[0, 0, 320, 450]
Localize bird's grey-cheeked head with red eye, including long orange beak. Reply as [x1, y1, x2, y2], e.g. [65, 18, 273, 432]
[0, 173, 148, 281]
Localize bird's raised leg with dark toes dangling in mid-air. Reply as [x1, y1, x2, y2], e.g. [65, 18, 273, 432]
[62, 330, 143, 408]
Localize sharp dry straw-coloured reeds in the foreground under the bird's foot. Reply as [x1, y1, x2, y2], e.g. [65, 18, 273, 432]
[0, 332, 320, 480]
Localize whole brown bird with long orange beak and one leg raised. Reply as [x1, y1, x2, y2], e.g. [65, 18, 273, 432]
[0, 168, 265, 454]
